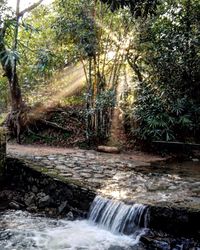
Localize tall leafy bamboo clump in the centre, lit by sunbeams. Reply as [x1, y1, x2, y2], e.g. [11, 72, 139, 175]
[54, 0, 132, 143]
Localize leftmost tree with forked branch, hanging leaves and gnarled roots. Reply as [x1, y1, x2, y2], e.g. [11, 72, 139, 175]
[0, 0, 43, 141]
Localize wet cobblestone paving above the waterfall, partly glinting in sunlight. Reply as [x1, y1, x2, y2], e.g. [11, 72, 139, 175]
[9, 145, 200, 209]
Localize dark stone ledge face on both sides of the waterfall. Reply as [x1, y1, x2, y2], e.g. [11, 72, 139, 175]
[3, 158, 200, 238]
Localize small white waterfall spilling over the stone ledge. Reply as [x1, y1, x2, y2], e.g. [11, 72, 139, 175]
[88, 196, 148, 235]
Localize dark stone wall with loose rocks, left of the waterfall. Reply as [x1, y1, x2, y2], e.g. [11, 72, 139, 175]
[4, 158, 95, 217]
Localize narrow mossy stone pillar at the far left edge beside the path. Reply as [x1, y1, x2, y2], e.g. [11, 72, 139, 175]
[0, 127, 6, 180]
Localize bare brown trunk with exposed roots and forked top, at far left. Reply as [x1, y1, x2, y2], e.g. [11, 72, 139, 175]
[0, 0, 43, 143]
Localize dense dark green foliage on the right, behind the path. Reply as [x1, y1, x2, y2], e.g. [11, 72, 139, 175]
[124, 0, 200, 144]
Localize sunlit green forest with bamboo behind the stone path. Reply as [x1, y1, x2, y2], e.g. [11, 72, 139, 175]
[0, 0, 200, 147]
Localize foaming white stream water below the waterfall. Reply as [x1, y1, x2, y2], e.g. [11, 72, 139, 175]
[0, 211, 145, 250]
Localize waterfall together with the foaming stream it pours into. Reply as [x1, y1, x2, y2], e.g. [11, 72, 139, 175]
[0, 197, 146, 250]
